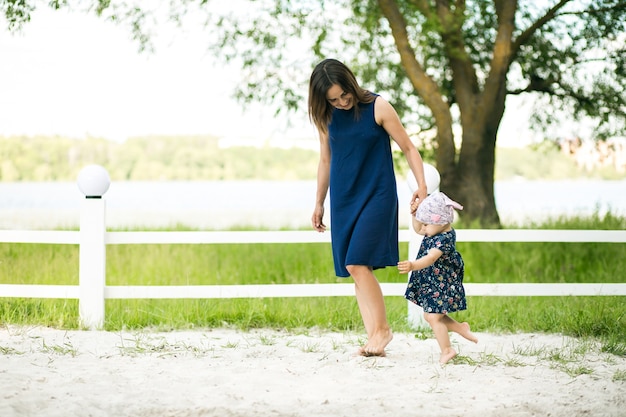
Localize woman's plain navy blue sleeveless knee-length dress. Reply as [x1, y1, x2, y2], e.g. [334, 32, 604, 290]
[328, 94, 398, 277]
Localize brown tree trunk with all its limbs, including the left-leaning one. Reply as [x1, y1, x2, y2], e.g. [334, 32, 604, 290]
[378, 0, 517, 228]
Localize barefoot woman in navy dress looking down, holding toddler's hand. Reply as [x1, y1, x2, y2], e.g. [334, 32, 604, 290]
[309, 59, 427, 356]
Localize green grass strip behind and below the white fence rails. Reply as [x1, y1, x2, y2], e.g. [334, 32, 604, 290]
[0, 214, 626, 356]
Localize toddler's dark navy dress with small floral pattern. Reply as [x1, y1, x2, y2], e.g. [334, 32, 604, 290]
[404, 229, 467, 314]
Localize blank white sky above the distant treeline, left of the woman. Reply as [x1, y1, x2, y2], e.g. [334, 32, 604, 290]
[0, 6, 532, 146]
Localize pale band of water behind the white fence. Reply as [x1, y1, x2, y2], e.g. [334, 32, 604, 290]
[0, 180, 626, 229]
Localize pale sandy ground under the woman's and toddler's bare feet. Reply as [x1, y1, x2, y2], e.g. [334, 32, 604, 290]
[0, 326, 626, 417]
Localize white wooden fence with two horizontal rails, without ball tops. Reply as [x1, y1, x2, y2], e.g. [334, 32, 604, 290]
[0, 198, 626, 329]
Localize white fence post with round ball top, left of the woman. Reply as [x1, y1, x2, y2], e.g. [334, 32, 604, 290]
[78, 165, 111, 330]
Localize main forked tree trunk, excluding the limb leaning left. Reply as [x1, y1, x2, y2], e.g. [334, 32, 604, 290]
[437, 0, 517, 228]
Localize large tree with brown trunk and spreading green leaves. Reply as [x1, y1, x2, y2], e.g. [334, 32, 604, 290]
[0, 0, 626, 227]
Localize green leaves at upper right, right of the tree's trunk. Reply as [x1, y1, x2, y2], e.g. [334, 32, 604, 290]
[511, 0, 626, 138]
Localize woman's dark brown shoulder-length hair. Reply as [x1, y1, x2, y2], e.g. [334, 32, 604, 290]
[309, 59, 375, 132]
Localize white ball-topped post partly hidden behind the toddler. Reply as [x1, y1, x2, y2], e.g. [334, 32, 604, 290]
[406, 163, 441, 330]
